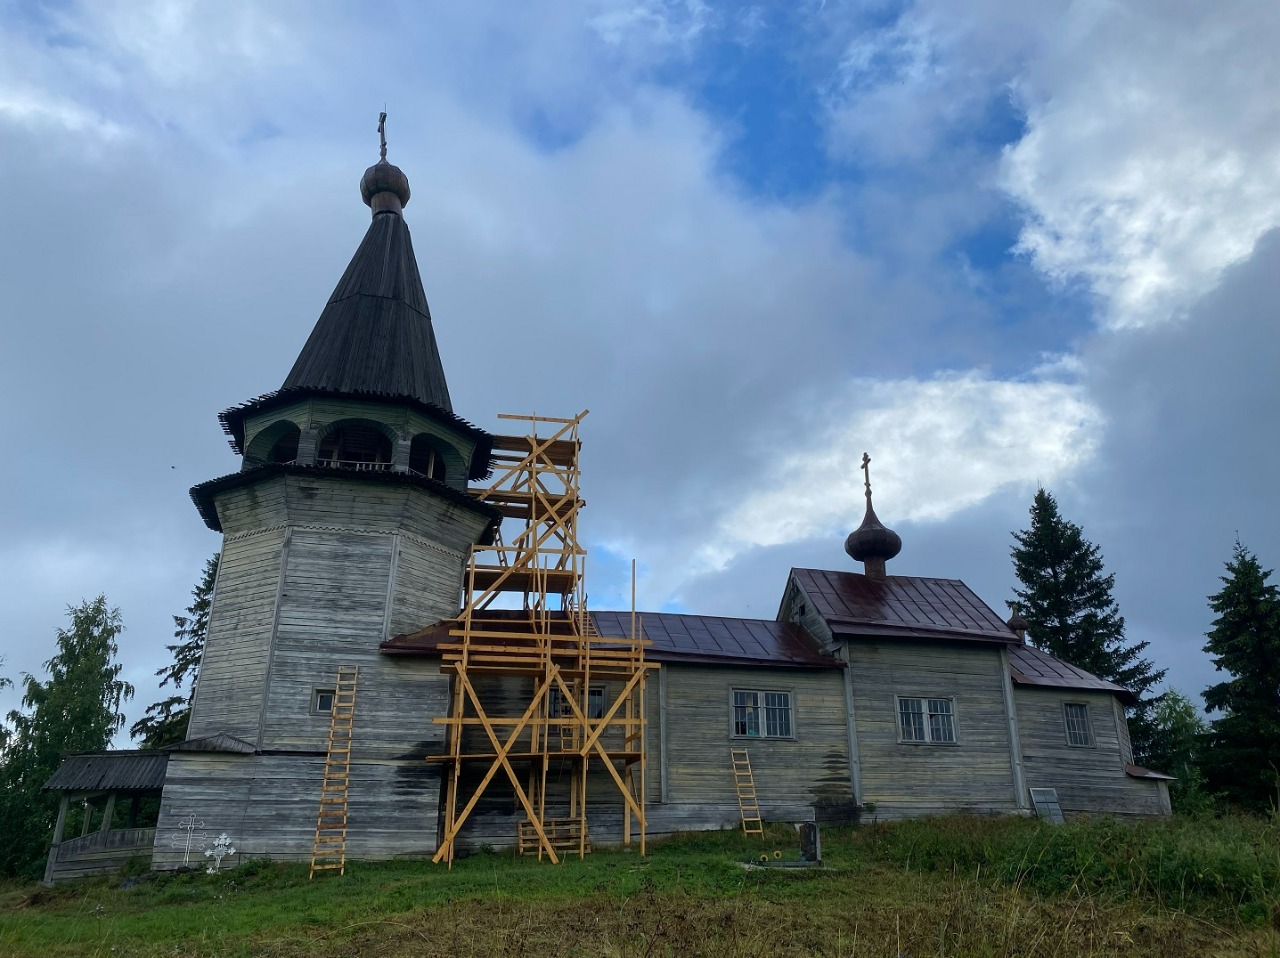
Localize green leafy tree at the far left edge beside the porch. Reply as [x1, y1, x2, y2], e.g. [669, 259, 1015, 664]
[0, 596, 133, 875]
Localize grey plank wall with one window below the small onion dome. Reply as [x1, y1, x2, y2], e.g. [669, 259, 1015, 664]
[847, 639, 1016, 818]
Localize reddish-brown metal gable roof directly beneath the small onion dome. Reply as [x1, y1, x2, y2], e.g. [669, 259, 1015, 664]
[791, 569, 1018, 643]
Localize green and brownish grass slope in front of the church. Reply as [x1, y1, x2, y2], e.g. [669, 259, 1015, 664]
[0, 817, 1280, 958]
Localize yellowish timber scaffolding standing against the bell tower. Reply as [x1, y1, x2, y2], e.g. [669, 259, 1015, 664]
[428, 411, 649, 865]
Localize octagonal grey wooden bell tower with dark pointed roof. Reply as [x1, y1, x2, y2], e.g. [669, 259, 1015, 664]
[156, 114, 500, 867]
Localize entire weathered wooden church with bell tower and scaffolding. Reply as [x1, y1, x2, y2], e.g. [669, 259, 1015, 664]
[46, 129, 1169, 880]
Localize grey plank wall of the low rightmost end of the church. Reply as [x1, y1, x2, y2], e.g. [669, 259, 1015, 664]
[1014, 685, 1167, 816]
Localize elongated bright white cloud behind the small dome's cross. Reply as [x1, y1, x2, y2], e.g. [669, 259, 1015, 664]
[699, 371, 1103, 569]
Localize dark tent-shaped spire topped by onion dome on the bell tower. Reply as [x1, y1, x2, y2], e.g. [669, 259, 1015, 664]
[282, 113, 453, 412]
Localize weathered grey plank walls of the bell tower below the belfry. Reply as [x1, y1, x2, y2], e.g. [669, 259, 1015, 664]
[167, 475, 486, 867]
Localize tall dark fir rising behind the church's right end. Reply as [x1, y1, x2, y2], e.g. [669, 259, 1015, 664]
[1007, 489, 1165, 762]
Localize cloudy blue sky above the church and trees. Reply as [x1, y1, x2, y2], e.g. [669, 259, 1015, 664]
[0, 0, 1280, 732]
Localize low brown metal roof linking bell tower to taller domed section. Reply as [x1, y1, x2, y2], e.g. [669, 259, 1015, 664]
[381, 610, 845, 669]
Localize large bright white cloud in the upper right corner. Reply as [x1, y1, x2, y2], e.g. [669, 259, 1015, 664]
[1002, 0, 1280, 327]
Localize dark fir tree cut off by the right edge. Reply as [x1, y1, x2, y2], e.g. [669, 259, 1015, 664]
[1204, 539, 1280, 811]
